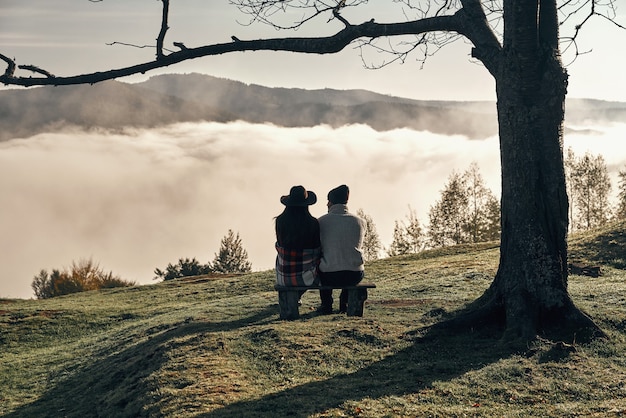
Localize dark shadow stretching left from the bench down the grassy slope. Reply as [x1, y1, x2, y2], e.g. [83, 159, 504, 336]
[3, 306, 278, 418]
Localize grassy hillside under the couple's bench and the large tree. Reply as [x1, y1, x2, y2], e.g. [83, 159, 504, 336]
[0, 224, 626, 417]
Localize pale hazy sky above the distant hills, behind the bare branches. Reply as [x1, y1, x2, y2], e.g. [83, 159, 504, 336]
[0, 0, 626, 101]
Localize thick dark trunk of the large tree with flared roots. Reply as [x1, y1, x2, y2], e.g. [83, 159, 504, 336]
[446, 0, 602, 341]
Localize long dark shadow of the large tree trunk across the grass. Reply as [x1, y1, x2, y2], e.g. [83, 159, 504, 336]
[198, 330, 513, 418]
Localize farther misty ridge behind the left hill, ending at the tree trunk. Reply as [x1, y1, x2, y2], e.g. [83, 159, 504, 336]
[138, 74, 497, 138]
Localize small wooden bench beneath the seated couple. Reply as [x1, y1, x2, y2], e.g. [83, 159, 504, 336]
[274, 282, 376, 319]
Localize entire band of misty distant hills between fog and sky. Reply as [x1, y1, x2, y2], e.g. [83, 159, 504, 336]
[0, 74, 626, 140]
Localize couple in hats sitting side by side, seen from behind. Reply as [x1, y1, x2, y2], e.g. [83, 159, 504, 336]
[276, 185, 365, 314]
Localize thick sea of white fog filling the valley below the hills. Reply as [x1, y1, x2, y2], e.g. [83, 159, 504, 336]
[0, 119, 626, 298]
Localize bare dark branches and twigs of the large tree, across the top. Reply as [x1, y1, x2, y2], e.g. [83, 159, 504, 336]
[0, 0, 626, 86]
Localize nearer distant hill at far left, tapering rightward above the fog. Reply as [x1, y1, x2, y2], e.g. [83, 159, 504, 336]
[0, 81, 235, 140]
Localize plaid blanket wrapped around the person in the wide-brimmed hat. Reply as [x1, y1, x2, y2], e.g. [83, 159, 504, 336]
[276, 243, 322, 286]
